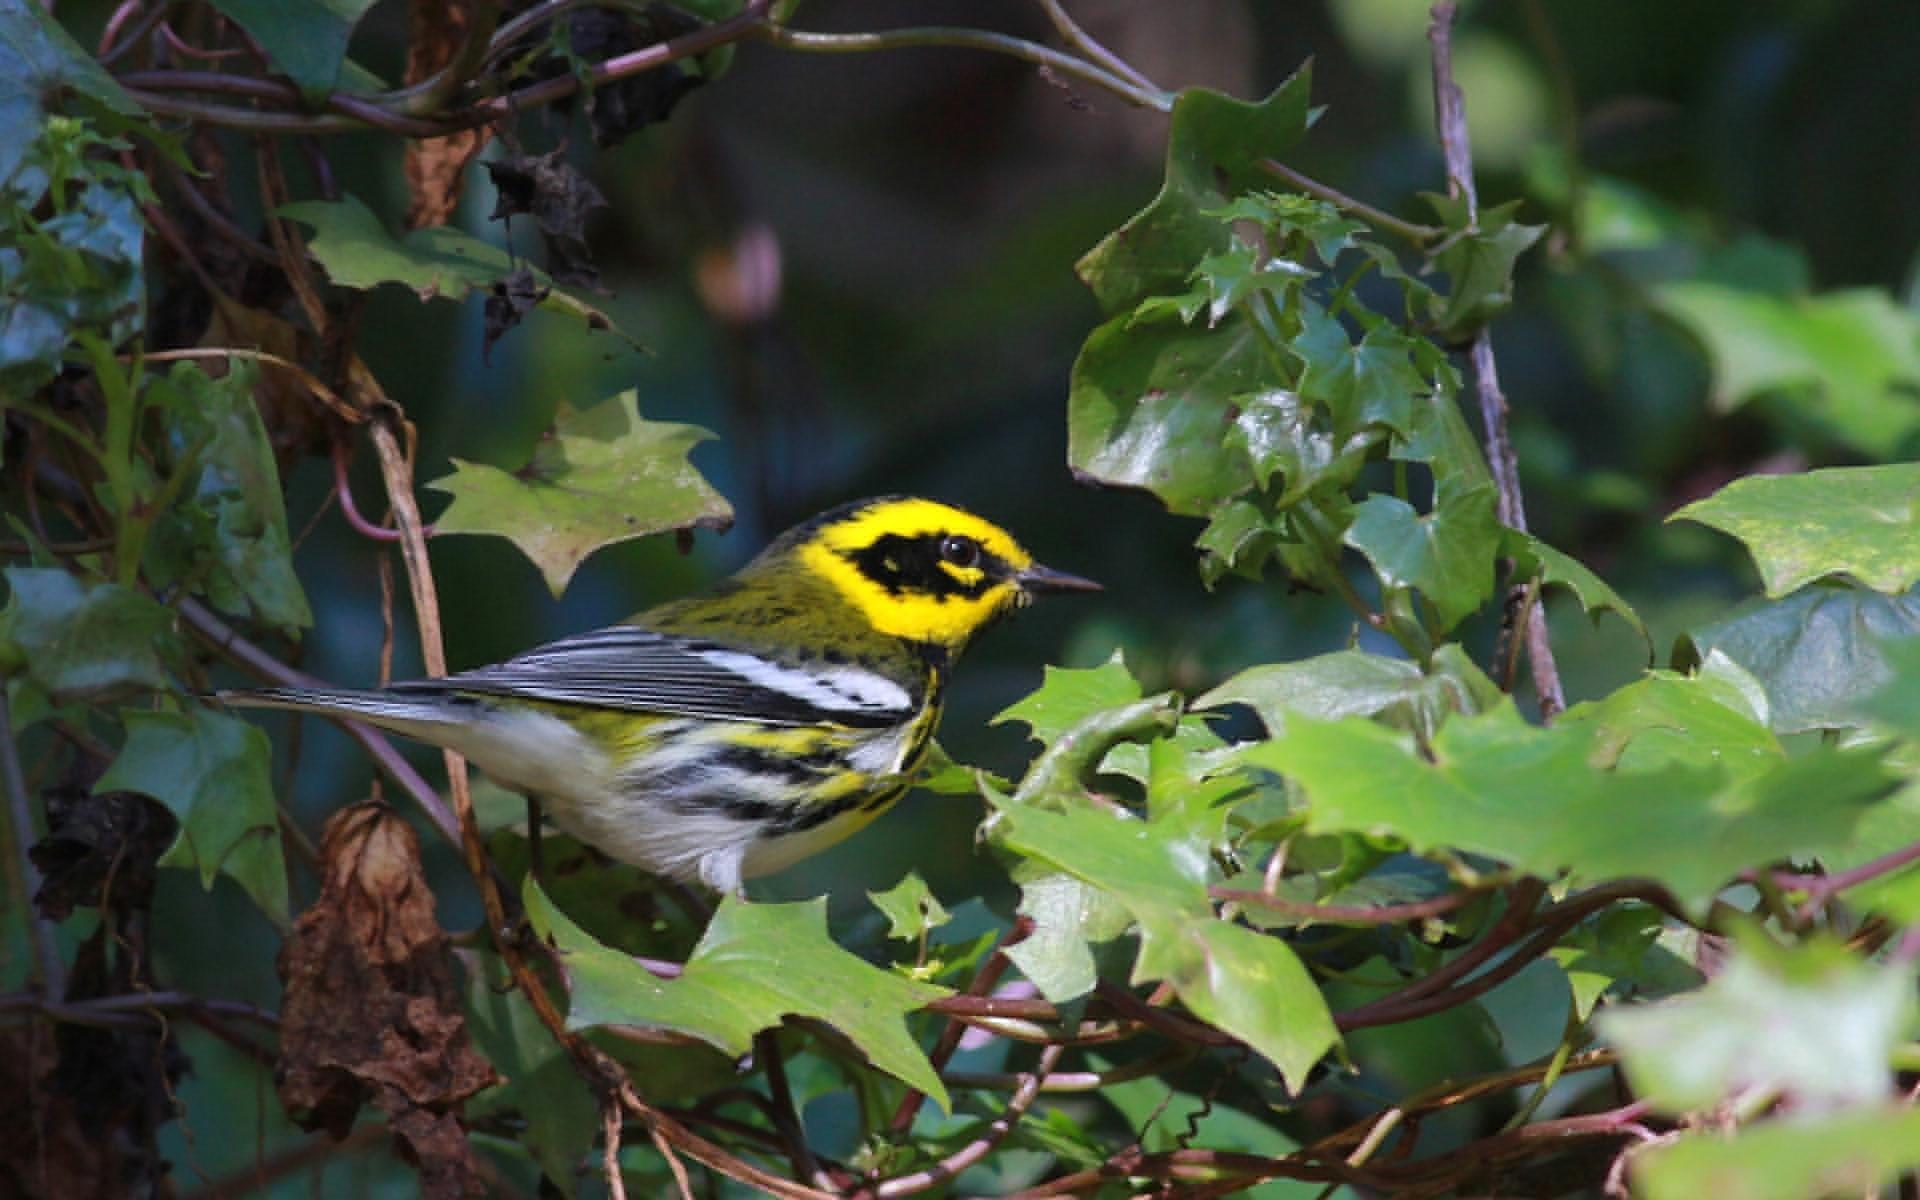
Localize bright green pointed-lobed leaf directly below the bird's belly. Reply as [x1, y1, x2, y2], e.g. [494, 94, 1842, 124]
[522, 876, 950, 1108]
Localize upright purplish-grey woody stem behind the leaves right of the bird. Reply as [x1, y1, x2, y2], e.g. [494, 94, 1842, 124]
[1427, 0, 1567, 720]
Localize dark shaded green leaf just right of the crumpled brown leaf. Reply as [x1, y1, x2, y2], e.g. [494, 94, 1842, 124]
[463, 952, 591, 1194]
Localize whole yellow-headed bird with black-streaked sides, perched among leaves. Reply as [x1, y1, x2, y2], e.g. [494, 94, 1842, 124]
[219, 495, 1100, 893]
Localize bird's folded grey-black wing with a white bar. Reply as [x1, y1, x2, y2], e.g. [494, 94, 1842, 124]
[394, 626, 916, 728]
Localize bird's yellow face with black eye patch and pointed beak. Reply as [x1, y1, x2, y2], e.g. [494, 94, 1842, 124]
[799, 497, 1059, 649]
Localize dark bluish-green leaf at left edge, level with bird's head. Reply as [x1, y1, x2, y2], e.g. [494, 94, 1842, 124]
[0, 566, 173, 701]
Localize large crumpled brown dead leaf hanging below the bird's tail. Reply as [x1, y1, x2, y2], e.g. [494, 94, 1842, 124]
[276, 803, 499, 1198]
